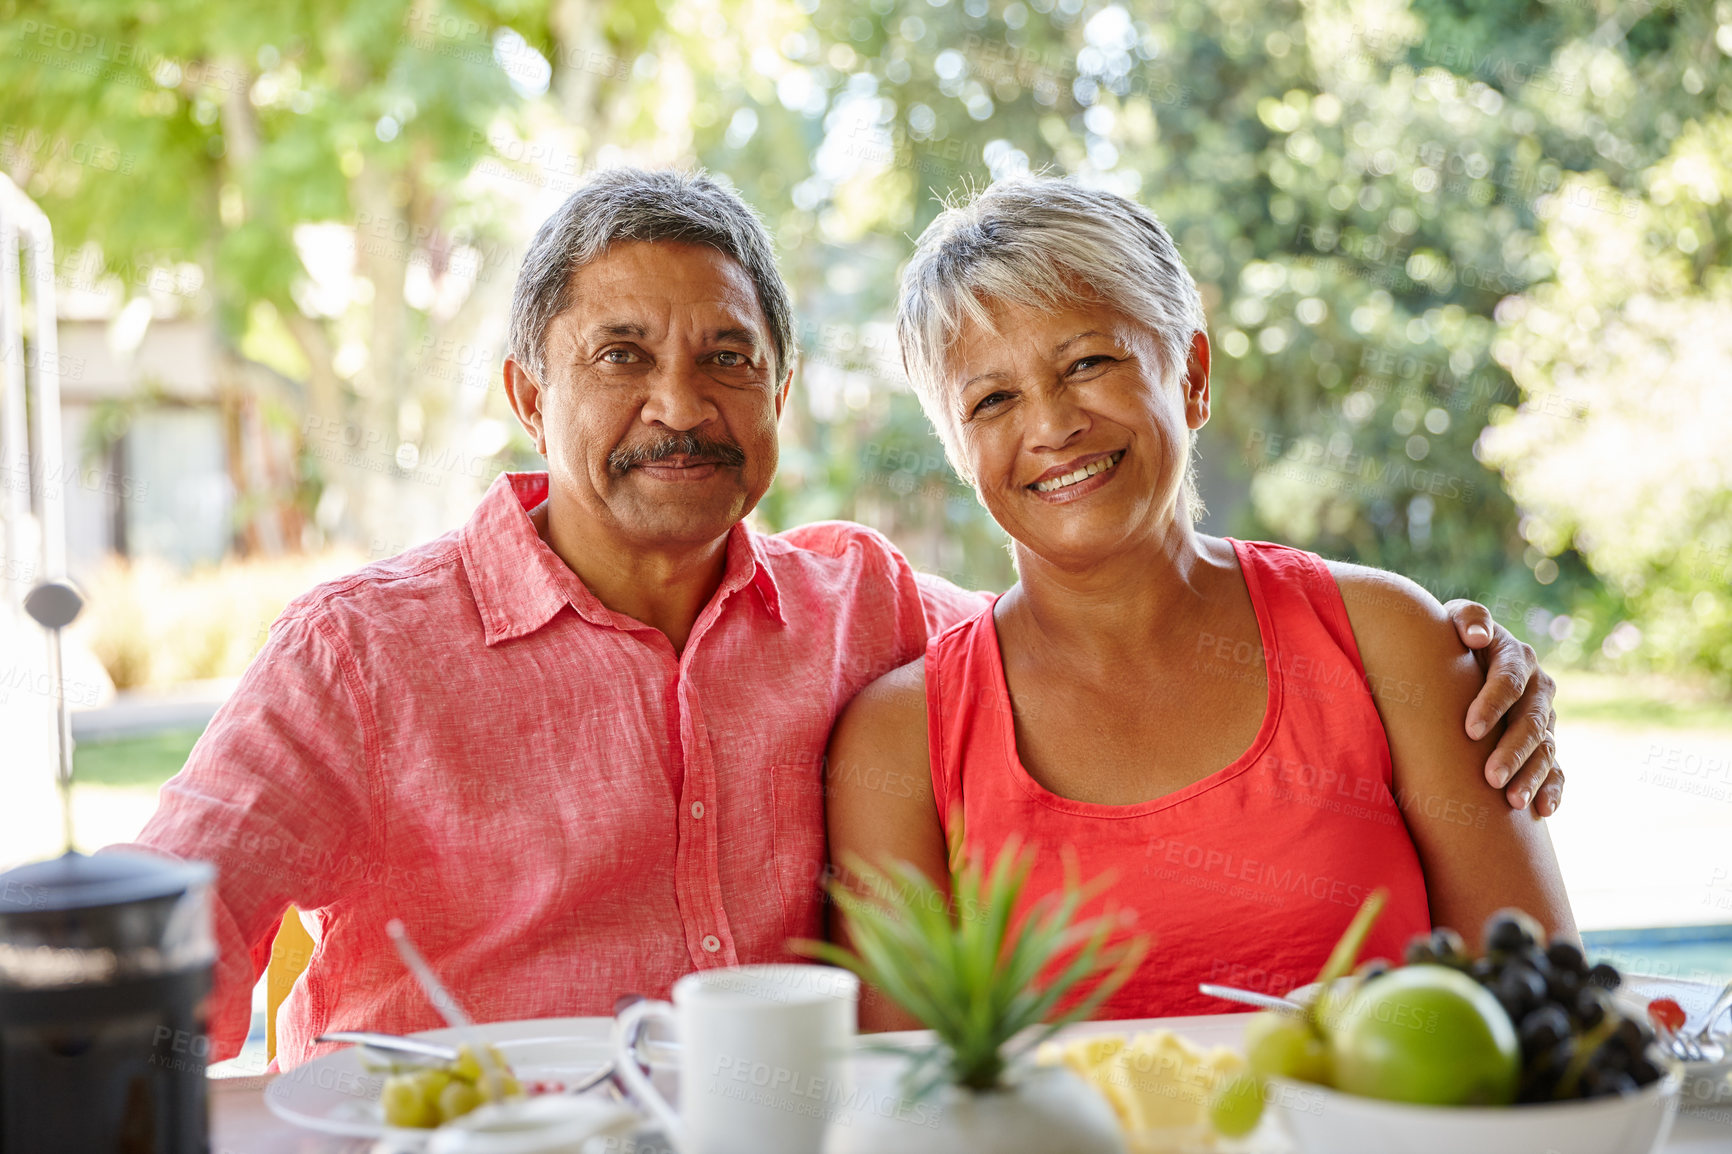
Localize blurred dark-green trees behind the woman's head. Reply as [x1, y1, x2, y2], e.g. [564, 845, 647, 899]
[713, 0, 1732, 639]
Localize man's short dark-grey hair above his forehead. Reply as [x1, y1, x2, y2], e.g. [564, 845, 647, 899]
[506, 168, 795, 385]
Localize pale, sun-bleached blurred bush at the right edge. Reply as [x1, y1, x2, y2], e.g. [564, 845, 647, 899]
[1483, 116, 1732, 688]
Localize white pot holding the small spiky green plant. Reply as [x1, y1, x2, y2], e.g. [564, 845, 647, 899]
[824, 1060, 1124, 1154]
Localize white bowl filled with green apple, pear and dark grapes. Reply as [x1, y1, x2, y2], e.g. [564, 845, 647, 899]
[1211, 896, 1678, 1154]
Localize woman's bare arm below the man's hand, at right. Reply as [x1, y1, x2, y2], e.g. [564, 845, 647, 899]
[1330, 563, 1576, 946]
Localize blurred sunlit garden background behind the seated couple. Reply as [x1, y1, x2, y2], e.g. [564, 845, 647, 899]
[0, 0, 1732, 1032]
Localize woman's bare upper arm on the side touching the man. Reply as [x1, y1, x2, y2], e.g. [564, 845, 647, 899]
[824, 660, 949, 1031]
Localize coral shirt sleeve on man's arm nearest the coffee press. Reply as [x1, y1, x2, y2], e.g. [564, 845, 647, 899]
[107, 615, 376, 1060]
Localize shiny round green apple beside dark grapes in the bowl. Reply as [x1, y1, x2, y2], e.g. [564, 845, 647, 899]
[1330, 965, 1521, 1105]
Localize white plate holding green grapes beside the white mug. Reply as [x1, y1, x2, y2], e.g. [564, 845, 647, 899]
[265, 1017, 674, 1149]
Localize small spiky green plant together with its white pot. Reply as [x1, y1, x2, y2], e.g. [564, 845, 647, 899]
[798, 825, 1148, 1154]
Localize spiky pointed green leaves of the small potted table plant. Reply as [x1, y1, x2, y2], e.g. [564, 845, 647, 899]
[797, 837, 1148, 1097]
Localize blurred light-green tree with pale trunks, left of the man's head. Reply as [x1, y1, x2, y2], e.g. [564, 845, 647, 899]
[0, 0, 662, 551]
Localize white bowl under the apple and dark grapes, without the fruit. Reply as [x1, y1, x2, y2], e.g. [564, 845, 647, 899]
[1268, 1074, 1678, 1154]
